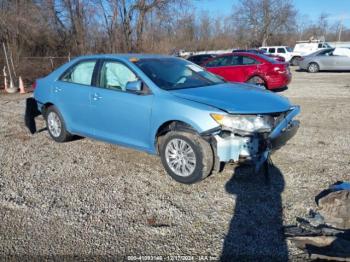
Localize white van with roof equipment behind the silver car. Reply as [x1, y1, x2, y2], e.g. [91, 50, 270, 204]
[290, 41, 332, 66]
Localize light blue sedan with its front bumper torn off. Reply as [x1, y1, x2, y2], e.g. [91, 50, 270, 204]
[34, 54, 299, 184]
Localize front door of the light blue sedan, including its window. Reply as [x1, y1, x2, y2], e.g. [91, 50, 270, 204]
[91, 60, 154, 150]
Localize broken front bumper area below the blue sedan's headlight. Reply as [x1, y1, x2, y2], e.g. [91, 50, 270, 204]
[208, 106, 300, 171]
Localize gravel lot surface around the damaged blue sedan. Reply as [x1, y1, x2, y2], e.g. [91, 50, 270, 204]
[0, 69, 350, 261]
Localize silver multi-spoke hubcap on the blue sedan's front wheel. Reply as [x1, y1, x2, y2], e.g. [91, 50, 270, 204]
[165, 138, 196, 177]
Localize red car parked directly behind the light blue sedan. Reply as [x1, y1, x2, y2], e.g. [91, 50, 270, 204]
[202, 52, 292, 90]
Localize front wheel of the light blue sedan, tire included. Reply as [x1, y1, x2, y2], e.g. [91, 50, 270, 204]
[160, 131, 214, 184]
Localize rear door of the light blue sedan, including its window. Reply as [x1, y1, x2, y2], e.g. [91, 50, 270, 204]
[52, 60, 97, 136]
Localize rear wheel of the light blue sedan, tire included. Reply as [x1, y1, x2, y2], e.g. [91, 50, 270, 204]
[45, 106, 72, 143]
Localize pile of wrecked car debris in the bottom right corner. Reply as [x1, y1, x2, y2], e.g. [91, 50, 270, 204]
[284, 182, 350, 261]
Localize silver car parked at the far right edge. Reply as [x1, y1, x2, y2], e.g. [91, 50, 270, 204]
[299, 48, 350, 73]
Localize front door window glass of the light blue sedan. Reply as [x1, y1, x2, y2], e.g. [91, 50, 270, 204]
[100, 62, 138, 91]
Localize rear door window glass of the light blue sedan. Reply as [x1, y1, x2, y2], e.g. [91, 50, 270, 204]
[60, 61, 96, 85]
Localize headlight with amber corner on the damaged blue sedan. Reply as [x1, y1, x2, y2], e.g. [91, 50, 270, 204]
[210, 114, 274, 133]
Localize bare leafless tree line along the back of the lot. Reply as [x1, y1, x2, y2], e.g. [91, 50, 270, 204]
[0, 0, 350, 60]
